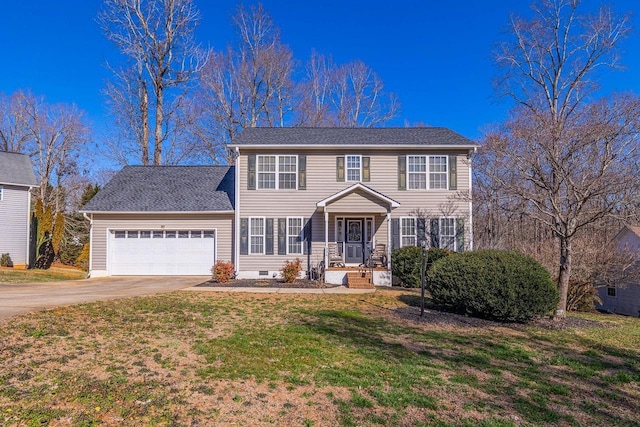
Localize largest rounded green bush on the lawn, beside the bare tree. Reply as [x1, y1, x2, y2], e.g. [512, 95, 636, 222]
[427, 250, 558, 322]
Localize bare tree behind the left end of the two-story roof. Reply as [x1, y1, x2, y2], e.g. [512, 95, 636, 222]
[192, 5, 294, 162]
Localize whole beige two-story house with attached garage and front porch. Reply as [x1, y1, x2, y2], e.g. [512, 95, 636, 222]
[84, 128, 477, 285]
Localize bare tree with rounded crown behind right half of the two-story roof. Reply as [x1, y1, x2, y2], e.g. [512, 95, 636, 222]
[300, 52, 399, 127]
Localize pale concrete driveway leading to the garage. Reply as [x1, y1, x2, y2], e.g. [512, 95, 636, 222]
[0, 276, 210, 320]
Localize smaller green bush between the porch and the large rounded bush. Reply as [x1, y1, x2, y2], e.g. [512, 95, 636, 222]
[391, 246, 453, 288]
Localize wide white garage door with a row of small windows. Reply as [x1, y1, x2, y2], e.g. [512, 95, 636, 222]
[109, 230, 216, 276]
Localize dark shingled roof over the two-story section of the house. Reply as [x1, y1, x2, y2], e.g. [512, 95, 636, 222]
[229, 127, 478, 148]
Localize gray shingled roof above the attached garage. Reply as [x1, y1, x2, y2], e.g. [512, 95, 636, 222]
[81, 166, 235, 213]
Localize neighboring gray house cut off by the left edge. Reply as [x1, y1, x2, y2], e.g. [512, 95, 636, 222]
[0, 151, 38, 268]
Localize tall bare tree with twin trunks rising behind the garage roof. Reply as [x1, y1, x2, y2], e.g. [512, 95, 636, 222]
[99, 0, 206, 165]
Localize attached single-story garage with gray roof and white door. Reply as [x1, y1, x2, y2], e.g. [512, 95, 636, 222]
[82, 166, 235, 277]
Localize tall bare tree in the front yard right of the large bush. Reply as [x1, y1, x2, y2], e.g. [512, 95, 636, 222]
[479, 0, 640, 316]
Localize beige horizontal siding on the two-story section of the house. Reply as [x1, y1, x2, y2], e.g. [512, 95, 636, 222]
[237, 147, 470, 272]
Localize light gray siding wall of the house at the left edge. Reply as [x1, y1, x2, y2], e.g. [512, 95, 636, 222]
[0, 185, 29, 266]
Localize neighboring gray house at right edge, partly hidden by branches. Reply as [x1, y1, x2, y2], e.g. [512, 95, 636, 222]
[597, 225, 640, 317]
